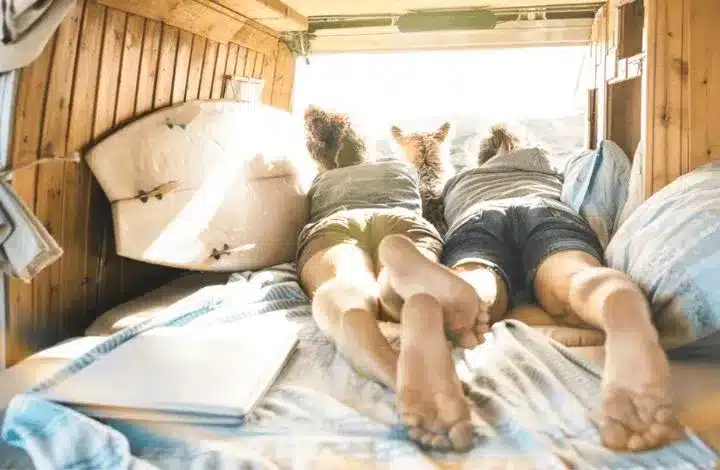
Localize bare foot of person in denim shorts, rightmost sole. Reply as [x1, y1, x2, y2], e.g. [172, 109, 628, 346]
[600, 332, 685, 452]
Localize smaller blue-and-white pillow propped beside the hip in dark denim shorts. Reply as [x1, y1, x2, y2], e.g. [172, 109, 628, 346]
[561, 140, 630, 248]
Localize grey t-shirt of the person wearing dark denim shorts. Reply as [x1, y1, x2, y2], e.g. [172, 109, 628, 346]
[444, 148, 562, 228]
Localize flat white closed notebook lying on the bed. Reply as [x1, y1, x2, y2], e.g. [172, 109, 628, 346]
[35, 315, 299, 424]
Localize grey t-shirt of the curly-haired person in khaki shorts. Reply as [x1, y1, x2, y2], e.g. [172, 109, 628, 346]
[308, 161, 422, 223]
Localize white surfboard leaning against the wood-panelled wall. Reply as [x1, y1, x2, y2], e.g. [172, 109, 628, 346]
[86, 100, 316, 271]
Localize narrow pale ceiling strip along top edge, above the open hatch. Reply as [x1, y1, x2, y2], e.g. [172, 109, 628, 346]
[284, 0, 594, 17]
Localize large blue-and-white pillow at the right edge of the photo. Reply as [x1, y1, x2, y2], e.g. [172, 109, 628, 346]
[605, 161, 720, 348]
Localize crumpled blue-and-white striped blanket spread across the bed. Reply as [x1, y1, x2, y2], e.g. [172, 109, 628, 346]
[2, 265, 717, 470]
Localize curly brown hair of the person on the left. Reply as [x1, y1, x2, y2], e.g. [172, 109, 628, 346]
[305, 106, 367, 171]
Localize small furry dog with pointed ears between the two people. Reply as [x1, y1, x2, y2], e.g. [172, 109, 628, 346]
[391, 122, 455, 234]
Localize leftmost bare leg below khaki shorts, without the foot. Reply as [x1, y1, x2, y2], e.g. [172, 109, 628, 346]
[300, 244, 398, 389]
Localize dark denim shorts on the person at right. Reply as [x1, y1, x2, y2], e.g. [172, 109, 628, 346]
[442, 197, 603, 297]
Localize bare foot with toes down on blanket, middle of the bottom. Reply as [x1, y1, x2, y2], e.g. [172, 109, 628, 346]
[397, 294, 473, 451]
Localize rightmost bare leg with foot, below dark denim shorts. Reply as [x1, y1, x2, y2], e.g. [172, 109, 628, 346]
[533, 251, 683, 451]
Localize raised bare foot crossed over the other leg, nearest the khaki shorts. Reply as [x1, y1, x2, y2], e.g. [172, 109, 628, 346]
[378, 235, 490, 348]
